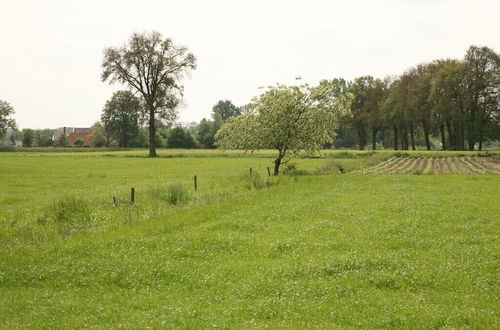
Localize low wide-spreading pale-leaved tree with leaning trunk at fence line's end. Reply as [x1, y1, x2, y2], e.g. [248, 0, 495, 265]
[216, 83, 351, 175]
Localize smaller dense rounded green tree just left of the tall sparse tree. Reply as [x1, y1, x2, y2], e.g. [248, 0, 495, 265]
[101, 91, 141, 148]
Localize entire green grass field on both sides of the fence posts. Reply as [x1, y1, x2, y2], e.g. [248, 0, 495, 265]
[0, 150, 500, 329]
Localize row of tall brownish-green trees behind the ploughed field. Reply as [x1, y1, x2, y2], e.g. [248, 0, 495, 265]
[336, 46, 500, 150]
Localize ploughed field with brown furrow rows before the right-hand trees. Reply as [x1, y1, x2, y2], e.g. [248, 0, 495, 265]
[362, 157, 500, 174]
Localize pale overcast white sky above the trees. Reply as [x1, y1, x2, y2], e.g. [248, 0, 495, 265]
[0, 0, 500, 129]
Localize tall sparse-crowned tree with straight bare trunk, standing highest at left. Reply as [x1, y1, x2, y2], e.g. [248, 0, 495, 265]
[101, 32, 196, 157]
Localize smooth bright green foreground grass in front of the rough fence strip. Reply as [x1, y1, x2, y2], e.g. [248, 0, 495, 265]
[0, 175, 500, 329]
